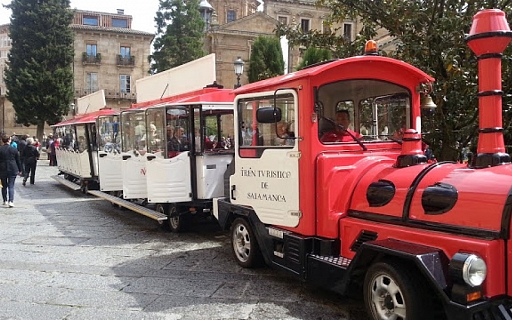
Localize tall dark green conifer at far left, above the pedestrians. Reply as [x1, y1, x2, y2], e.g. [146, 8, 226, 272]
[5, 0, 74, 137]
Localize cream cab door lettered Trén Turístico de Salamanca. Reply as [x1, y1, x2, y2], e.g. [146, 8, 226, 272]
[230, 90, 301, 227]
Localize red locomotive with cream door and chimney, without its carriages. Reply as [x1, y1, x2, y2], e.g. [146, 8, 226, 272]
[213, 9, 512, 320]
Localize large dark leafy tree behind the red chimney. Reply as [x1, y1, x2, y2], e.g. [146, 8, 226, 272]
[277, 0, 512, 160]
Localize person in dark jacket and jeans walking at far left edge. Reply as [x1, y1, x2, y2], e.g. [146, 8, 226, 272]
[0, 135, 21, 208]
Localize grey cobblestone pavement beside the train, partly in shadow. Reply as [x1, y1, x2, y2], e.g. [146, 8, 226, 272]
[0, 160, 367, 320]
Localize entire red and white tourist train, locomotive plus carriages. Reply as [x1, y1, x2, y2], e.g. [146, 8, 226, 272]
[55, 10, 512, 320]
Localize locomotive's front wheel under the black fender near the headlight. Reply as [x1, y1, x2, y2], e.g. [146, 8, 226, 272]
[363, 261, 433, 320]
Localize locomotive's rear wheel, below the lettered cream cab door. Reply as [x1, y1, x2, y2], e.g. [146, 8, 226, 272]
[231, 218, 263, 268]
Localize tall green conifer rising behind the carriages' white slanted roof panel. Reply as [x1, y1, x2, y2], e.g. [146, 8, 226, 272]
[149, 0, 205, 74]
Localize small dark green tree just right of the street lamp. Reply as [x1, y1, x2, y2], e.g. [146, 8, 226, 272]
[248, 36, 284, 82]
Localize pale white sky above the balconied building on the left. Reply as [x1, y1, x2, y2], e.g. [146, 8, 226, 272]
[0, 0, 159, 33]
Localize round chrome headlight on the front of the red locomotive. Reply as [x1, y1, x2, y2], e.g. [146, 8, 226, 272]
[450, 253, 487, 287]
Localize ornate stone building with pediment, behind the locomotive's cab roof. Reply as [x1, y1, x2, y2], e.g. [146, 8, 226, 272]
[201, 0, 361, 88]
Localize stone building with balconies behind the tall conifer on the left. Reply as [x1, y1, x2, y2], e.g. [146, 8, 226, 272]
[0, 10, 154, 135]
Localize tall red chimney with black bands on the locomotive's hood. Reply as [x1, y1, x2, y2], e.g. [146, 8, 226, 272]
[466, 9, 512, 168]
